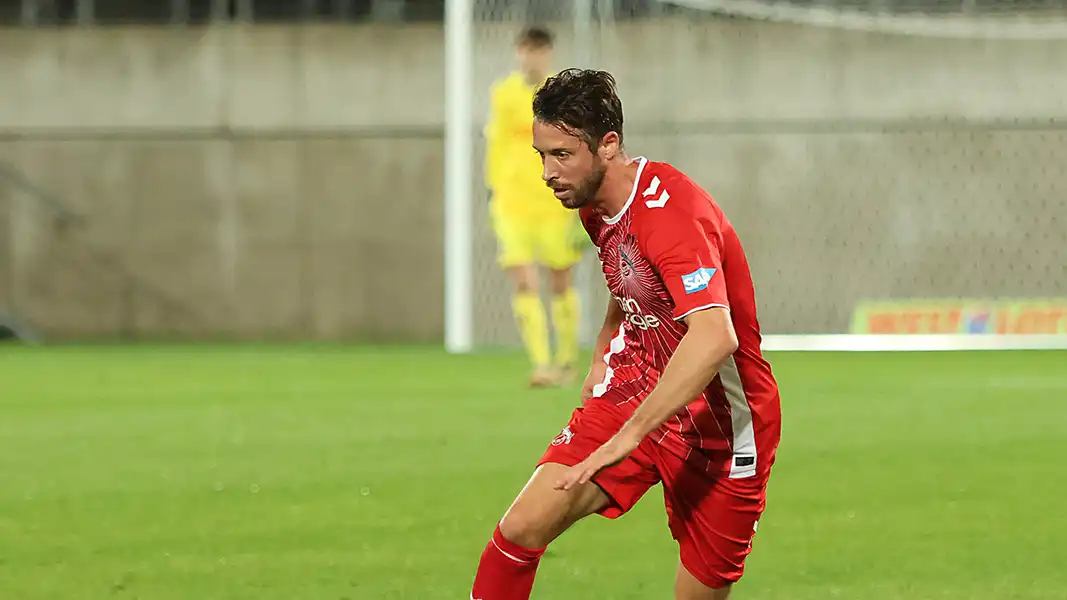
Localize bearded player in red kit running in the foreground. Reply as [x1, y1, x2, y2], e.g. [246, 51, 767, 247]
[471, 69, 781, 600]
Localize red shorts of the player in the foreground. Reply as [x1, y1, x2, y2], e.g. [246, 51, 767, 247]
[539, 392, 774, 589]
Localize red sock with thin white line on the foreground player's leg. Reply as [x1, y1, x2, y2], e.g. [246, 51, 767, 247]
[471, 525, 544, 600]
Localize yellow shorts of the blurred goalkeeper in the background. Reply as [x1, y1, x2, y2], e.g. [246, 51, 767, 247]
[492, 210, 585, 269]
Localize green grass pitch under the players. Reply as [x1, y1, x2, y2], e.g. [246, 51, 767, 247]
[0, 345, 1067, 600]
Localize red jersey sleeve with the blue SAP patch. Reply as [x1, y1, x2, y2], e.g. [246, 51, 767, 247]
[638, 191, 730, 320]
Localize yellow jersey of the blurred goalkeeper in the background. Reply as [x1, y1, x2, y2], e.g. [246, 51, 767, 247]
[484, 73, 573, 220]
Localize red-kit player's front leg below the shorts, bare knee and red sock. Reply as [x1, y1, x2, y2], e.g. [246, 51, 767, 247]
[471, 463, 608, 600]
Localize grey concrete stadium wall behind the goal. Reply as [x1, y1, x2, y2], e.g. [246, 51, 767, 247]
[0, 20, 1067, 342]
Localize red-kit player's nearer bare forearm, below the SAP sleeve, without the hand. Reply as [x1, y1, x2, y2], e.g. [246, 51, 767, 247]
[621, 310, 737, 439]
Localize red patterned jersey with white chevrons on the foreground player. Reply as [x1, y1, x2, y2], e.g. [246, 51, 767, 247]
[580, 158, 781, 477]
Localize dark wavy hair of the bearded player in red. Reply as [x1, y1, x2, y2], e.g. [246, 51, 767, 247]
[534, 68, 622, 152]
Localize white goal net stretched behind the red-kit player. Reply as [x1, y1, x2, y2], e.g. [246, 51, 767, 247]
[448, 0, 1067, 347]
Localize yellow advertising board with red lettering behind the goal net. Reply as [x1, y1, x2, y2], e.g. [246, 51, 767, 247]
[851, 298, 1067, 335]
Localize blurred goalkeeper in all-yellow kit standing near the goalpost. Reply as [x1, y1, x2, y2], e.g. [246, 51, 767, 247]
[485, 27, 584, 386]
